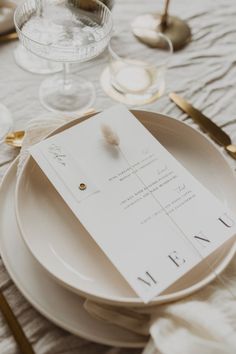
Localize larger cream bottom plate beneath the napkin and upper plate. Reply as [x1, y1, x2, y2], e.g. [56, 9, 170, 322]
[0, 161, 147, 347]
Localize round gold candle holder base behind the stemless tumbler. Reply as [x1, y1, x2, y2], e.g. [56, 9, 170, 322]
[131, 13, 191, 50]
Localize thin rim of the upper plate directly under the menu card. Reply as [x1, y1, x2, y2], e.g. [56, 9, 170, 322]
[15, 109, 236, 307]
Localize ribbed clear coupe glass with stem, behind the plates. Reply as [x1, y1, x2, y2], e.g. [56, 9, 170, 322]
[14, 0, 112, 112]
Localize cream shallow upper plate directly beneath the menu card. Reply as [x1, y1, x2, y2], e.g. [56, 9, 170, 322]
[16, 111, 236, 306]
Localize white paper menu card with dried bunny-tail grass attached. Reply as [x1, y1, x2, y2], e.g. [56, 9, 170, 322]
[30, 105, 236, 303]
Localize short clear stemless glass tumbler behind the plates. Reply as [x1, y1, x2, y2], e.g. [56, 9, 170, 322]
[101, 31, 173, 106]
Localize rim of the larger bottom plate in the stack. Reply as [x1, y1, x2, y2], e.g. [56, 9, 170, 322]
[0, 160, 148, 348]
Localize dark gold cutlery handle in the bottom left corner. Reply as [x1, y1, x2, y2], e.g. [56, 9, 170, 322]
[0, 291, 35, 354]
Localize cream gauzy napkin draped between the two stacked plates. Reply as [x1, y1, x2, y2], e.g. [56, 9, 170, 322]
[18, 114, 236, 354]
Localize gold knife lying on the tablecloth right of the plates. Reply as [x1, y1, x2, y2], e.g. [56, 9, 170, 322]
[169, 92, 236, 159]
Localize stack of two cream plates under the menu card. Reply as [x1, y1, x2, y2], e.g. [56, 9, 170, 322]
[0, 111, 236, 347]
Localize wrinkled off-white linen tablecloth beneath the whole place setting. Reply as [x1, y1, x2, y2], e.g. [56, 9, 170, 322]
[0, 0, 236, 354]
